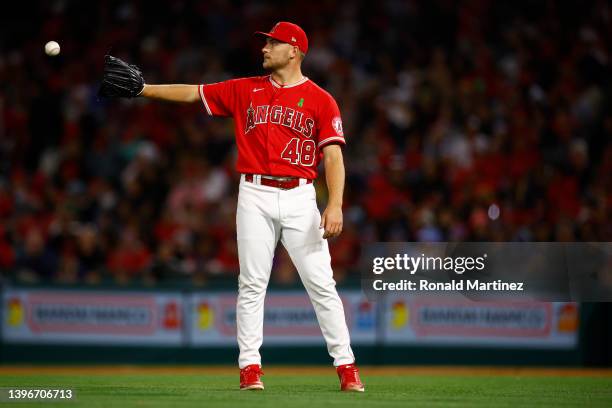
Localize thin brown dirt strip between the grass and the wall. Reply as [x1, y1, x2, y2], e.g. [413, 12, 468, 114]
[0, 365, 612, 377]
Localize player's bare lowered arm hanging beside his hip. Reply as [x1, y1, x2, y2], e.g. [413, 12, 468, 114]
[321, 144, 344, 238]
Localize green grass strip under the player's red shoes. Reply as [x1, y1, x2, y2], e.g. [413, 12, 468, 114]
[0, 369, 612, 408]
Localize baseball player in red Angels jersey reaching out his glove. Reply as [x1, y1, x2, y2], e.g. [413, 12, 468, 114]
[100, 22, 364, 391]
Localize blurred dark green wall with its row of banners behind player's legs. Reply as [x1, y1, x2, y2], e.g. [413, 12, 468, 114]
[1, 286, 600, 365]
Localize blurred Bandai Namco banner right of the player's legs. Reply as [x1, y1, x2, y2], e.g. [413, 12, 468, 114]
[383, 295, 579, 348]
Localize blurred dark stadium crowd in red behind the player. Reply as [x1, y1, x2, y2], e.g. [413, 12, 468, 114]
[0, 0, 612, 285]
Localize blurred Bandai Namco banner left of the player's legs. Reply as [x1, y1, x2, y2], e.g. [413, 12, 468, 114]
[2, 289, 183, 346]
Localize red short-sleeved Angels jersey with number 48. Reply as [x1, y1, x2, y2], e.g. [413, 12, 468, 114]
[199, 75, 345, 179]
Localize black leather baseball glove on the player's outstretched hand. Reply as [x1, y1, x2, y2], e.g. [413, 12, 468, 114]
[98, 55, 144, 98]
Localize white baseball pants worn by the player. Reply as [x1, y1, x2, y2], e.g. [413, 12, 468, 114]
[236, 175, 355, 368]
